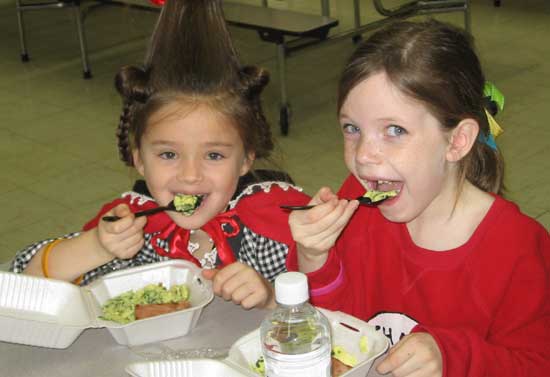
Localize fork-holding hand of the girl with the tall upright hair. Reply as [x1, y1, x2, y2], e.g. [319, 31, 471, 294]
[97, 204, 147, 259]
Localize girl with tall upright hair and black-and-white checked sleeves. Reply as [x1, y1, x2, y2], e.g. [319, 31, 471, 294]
[12, 0, 308, 308]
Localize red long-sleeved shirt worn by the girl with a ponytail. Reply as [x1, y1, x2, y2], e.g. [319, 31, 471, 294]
[287, 177, 550, 377]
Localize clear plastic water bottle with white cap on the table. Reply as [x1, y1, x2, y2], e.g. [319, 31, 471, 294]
[260, 272, 331, 377]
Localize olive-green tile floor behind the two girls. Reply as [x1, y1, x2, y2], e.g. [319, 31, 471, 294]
[0, 0, 550, 263]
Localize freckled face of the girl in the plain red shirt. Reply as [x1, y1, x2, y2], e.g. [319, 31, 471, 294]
[340, 73, 456, 223]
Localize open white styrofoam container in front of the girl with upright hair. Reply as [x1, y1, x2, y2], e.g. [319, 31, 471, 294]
[0, 260, 214, 348]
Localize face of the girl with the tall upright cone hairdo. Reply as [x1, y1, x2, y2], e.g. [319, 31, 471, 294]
[133, 103, 254, 229]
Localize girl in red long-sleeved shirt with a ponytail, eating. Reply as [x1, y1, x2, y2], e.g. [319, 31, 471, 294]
[289, 20, 550, 377]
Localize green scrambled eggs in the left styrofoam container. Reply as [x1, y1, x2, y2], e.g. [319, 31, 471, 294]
[99, 284, 190, 324]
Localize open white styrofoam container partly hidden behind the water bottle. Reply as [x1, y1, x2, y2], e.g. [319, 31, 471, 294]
[126, 309, 389, 377]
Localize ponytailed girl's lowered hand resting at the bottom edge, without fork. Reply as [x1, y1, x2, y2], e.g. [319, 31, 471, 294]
[376, 333, 443, 377]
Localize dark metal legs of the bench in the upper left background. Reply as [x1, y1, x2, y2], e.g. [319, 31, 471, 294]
[15, 0, 92, 79]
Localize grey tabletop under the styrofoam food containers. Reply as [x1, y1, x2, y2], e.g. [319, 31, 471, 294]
[0, 297, 388, 377]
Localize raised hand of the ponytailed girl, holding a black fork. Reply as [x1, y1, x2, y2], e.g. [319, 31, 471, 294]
[289, 187, 359, 272]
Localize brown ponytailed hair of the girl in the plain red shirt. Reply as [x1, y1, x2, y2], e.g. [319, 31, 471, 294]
[338, 20, 504, 193]
